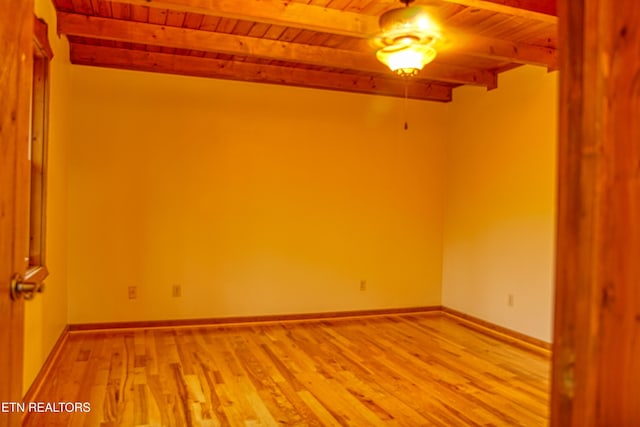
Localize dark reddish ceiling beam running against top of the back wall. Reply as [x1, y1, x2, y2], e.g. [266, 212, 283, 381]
[70, 43, 451, 102]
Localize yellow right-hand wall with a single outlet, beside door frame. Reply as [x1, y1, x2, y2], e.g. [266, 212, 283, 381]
[442, 67, 557, 341]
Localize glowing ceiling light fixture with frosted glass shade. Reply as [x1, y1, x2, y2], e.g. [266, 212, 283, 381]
[374, 0, 441, 77]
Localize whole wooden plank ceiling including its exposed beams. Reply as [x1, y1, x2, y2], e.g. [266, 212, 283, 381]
[54, 0, 558, 102]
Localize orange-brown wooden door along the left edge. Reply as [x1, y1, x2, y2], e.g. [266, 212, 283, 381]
[0, 0, 33, 427]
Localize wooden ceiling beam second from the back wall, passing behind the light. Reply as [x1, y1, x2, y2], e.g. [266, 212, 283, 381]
[58, 13, 497, 89]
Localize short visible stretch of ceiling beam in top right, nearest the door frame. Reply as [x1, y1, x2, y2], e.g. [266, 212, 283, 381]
[443, 0, 558, 24]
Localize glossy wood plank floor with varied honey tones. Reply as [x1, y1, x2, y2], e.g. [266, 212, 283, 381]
[24, 313, 550, 427]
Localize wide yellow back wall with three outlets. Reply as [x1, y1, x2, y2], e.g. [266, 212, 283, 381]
[69, 66, 447, 323]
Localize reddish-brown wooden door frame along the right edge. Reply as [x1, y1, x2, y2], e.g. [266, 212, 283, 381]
[551, 0, 640, 427]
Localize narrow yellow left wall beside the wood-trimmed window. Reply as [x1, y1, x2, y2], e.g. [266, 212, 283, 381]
[23, 0, 70, 392]
